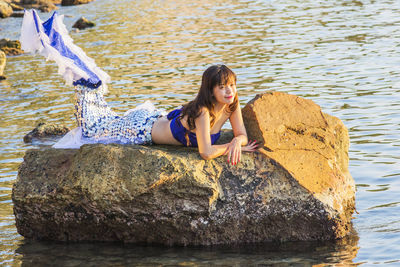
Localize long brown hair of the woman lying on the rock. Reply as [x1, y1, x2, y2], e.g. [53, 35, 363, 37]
[180, 65, 239, 130]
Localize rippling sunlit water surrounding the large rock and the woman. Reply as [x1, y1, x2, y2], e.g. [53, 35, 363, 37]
[0, 0, 400, 266]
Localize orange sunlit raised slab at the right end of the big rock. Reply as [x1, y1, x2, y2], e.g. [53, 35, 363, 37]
[243, 92, 355, 237]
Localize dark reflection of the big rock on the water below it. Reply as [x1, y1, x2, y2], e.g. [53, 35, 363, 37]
[15, 234, 359, 266]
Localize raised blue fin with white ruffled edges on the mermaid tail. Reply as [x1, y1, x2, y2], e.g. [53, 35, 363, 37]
[20, 10, 110, 92]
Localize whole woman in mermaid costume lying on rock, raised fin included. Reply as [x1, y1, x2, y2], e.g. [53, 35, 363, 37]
[21, 10, 257, 165]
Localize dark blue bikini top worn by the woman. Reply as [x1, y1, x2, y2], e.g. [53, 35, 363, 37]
[167, 109, 221, 147]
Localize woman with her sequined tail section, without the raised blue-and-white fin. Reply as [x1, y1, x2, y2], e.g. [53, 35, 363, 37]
[72, 65, 257, 165]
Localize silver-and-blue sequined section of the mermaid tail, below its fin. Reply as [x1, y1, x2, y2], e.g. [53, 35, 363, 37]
[75, 85, 164, 144]
